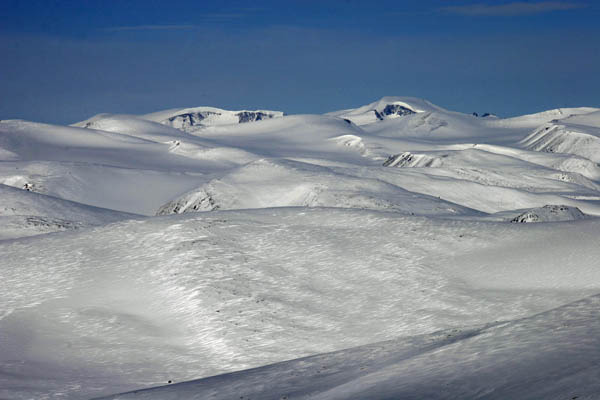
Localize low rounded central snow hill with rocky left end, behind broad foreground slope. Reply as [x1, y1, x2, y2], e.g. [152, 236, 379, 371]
[157, 159, 478, 215]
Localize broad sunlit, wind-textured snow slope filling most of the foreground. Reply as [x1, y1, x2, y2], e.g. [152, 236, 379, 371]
[0, 208, 600, 399]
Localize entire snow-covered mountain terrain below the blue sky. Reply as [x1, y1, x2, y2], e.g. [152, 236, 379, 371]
[0, 97, 600, 400]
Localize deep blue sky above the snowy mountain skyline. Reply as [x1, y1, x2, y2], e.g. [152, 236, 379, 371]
[0, 0, 600, 124]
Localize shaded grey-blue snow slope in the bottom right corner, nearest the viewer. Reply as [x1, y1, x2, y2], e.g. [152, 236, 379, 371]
[97, 296, 600, 400]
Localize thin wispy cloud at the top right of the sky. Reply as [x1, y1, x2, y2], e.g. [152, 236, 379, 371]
[439, 1, 586, 17]
